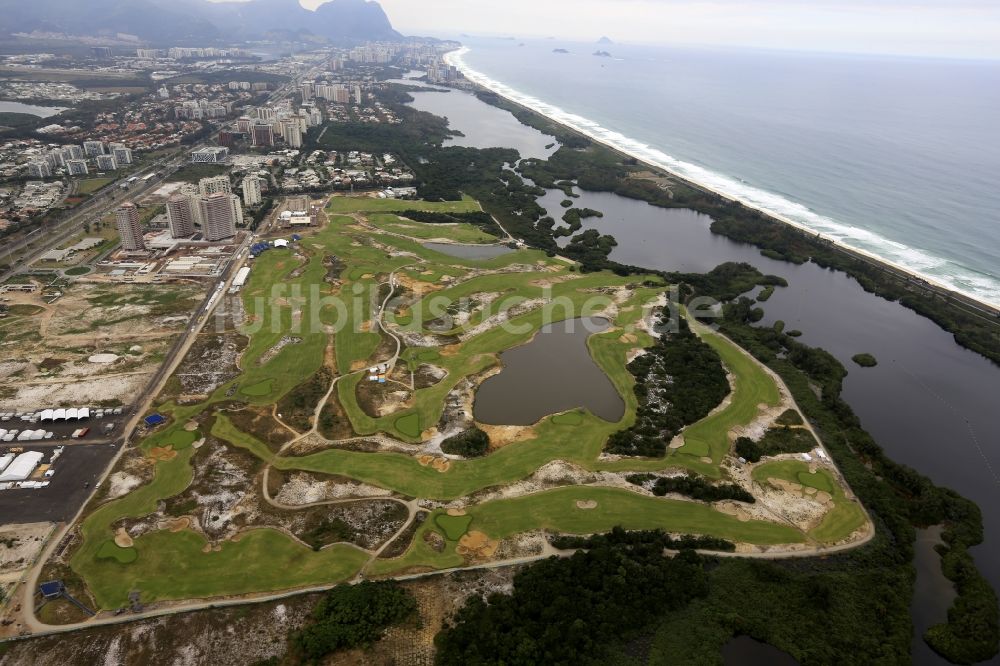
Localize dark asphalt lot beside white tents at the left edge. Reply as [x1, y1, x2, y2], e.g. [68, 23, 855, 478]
[0, 442, 119, 524]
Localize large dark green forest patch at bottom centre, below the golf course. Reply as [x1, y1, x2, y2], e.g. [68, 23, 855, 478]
[437, 539, 708, 666]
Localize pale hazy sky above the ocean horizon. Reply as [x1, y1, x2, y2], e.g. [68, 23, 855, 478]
[301, 0, 1000, 58]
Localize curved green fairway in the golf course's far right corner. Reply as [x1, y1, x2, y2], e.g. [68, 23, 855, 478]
[752, 460, 867, 543]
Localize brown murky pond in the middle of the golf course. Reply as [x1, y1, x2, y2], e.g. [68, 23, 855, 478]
[473, 317, 625, 425]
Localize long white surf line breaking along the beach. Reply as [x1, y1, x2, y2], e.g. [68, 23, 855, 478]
[444, 46, 1000, 309]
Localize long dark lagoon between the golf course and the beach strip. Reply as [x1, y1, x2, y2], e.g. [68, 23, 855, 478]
[414, 85, 1000, 664]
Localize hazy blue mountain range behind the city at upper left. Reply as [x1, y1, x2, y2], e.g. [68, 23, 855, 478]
[0, 0, 402, 44]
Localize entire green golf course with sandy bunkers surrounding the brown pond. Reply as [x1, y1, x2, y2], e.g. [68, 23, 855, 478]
[43, 196, 872, 622]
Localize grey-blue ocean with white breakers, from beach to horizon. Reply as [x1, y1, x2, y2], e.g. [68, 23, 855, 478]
[448, 39, 1000, 306]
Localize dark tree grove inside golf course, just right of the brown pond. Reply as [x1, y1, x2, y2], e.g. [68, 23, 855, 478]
[606, 319, 729, 456]
